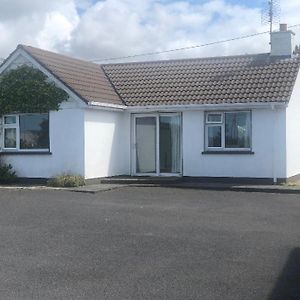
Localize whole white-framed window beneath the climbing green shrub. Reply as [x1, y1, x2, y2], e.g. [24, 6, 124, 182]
[3, 114, 49, 151]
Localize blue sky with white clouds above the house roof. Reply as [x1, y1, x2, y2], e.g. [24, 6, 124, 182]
[0, 0, 300, 60]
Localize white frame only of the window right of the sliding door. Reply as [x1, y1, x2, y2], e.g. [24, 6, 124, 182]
[204, 110, 252, 152]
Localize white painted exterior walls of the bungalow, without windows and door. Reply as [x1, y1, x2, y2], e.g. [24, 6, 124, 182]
[3, 47, 300, 178]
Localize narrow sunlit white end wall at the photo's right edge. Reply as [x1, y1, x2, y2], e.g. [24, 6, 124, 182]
[286, 74, 300, 177]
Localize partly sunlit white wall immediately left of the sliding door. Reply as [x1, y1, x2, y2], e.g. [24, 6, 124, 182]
[84, 109, 130, 179]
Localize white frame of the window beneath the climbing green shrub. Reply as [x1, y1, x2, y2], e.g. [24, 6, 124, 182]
[1, 113, 50, 152]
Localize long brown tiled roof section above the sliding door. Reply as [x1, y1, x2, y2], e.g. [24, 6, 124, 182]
[102, 54, 299, 106]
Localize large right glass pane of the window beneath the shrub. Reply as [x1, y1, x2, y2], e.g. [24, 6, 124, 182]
[20, 114, 49, 149]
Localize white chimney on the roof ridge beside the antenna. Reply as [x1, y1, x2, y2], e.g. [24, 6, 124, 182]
[271, 24, 295, 57]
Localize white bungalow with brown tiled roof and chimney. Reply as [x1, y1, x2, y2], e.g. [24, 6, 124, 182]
[0, 26, 300, 182]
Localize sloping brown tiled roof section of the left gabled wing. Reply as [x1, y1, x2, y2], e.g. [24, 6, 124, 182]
[19, 45, 124, 105]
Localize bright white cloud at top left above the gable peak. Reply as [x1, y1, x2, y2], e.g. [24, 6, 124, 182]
[0, 0, 79, 57]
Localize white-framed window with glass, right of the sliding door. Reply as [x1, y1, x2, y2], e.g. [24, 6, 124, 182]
[205, 111, 251, 150]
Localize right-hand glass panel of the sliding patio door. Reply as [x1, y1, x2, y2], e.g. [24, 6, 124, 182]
[159, 115, 181, 173]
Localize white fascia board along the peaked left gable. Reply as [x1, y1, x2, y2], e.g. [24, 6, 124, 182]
[0, 48, 87, 108]
